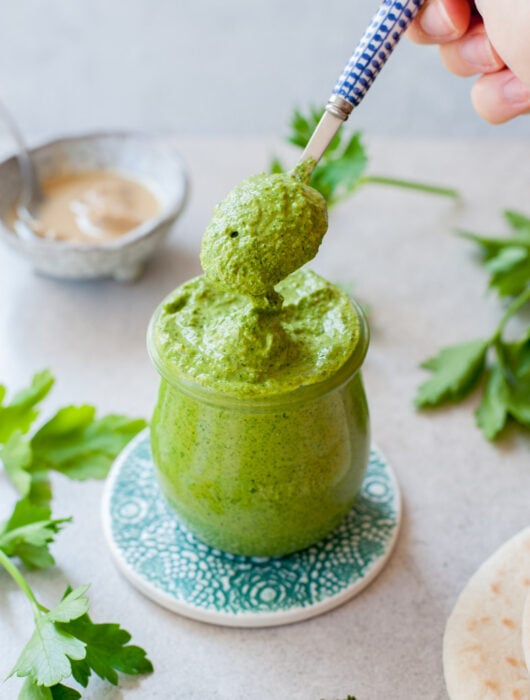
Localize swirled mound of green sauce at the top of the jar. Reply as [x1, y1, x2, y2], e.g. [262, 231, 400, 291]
[154, 269, 361, 396]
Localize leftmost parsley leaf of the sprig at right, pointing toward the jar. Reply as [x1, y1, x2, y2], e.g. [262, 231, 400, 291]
[416, 340, 489, 406]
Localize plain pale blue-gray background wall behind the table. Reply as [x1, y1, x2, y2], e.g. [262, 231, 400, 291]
[0, 0, 530, 141]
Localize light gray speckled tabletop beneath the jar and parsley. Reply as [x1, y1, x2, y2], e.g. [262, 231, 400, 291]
[0, 139, 530, 700]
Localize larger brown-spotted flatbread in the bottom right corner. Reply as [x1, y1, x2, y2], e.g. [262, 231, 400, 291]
[444, 528, 530, 700]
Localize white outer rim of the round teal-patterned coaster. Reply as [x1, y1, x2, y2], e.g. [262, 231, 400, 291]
[101, 428, 402, 627]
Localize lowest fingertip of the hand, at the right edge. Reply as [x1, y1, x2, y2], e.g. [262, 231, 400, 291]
[471, 69, 530, 124]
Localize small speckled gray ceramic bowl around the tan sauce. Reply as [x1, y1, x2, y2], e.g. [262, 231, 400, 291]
[0, 132, 188, 281]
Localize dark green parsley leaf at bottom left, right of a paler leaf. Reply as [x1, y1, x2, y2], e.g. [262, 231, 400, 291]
[61, 615, 153, 688]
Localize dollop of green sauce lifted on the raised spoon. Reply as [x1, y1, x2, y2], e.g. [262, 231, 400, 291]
[201, 169, 328, 296]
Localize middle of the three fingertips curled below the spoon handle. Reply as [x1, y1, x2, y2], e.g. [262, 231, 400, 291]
[440, 20, 504, 77]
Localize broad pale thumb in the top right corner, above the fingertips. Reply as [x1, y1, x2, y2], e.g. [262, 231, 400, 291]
[475, 0, 530, 87]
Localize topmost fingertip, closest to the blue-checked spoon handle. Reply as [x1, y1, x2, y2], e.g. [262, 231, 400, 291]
[407, 0, 471, 44]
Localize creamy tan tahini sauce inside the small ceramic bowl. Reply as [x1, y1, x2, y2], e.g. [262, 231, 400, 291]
[30, 170, 160, 243]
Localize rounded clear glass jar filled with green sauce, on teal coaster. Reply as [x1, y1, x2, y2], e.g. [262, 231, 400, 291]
[148, 296, 370, 557]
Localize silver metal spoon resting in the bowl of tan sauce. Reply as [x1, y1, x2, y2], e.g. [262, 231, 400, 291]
[0, 102, 43, 241]
